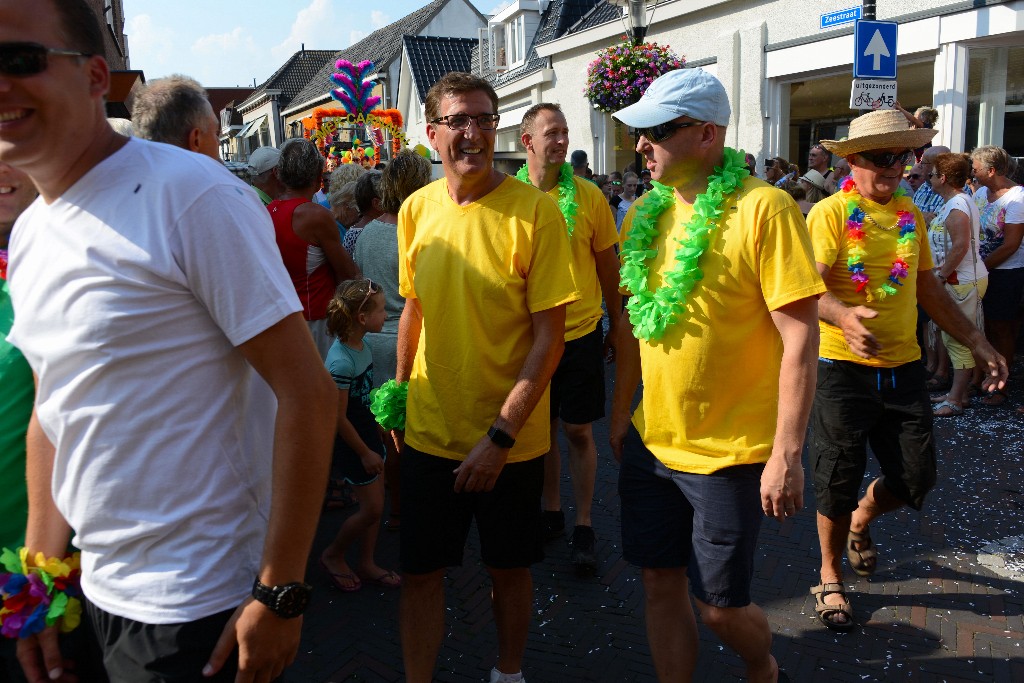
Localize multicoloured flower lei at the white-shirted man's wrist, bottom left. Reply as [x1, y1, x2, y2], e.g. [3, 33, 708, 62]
[0, 548, 82, 638]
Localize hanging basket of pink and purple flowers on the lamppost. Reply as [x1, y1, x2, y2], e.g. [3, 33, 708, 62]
[584, 41, 686, 114]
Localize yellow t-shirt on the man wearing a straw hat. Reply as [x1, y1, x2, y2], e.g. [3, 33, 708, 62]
[807, 193, 935, 368]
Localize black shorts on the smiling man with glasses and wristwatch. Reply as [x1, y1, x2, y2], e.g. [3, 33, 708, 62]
[400, 445, 544, 573]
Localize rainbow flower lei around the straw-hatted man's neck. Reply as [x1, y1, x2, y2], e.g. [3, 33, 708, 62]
[841, 176, 916, 303]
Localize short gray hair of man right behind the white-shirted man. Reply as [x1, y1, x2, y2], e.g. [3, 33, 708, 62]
[131, 74, 212, 147]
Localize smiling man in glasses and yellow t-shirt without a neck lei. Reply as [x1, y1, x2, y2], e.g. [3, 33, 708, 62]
[397, 73, 579, 683]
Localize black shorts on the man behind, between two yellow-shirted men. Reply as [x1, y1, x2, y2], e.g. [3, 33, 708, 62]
[551, 321, 604, 425]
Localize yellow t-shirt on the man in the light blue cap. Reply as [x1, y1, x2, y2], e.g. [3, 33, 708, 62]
[623, 178, 825, 474]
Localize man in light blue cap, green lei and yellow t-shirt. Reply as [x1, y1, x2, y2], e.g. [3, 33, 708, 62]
[609, 69, 824, 682]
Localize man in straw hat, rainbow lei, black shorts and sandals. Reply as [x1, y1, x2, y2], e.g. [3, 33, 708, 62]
[807, 110, 1007, 631]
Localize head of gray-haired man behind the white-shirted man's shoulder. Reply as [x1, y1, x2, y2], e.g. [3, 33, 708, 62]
[131, 74, 220, 162]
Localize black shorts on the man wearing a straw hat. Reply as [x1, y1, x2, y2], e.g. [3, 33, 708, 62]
[810, 358, 936, 517]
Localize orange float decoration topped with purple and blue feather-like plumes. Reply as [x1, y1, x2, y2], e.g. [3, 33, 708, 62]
[302, 59, 406, 168]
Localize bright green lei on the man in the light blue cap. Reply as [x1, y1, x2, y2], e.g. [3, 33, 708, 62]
[620, 147, 751, 341]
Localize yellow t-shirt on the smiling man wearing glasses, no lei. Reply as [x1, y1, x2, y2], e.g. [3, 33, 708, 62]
[398, 178, 579, 463]
